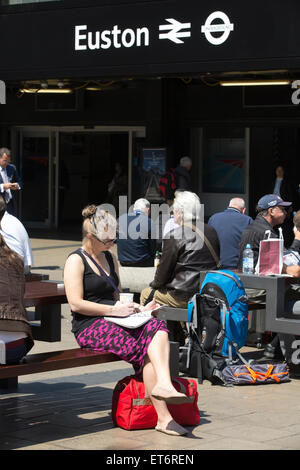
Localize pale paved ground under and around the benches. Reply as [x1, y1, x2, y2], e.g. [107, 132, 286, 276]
[0, 237, 300, 452]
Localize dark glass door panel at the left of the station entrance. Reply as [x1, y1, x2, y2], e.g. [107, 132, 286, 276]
[18, 129, 56, 228]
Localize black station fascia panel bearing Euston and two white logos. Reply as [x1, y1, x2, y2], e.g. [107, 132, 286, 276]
[0, 0, 300, 82]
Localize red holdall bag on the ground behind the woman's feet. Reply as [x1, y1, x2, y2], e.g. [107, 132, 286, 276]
[112, 375, 200, 429]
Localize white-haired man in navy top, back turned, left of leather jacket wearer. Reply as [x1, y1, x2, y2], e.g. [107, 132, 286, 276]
[117, 198, 156, 267]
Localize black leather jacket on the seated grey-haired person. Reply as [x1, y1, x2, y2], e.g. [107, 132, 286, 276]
[150, 224, 220, 300]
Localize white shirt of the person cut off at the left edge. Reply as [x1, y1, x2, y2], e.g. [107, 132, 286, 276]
[0, 211, 33, 271]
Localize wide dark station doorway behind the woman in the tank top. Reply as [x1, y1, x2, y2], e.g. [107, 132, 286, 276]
[12, 126, 145, 229]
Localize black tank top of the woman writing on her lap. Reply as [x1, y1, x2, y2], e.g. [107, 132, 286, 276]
[71, 250, 119, 336]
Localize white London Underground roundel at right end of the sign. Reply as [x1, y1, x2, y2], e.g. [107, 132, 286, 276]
[201, 11, 234, 46]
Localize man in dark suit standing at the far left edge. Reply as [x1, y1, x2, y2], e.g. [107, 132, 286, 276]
[0, 147, 21, 216]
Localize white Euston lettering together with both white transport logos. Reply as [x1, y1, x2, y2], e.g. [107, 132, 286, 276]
[75, 11, 234, 51]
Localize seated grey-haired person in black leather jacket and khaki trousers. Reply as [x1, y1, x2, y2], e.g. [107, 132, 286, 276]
[141, 191, 220, 344]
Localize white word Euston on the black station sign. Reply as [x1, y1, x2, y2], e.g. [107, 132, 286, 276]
[75, 25, 149, 51]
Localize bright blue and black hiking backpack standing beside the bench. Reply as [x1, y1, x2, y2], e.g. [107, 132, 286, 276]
[179, 270, 248, 383]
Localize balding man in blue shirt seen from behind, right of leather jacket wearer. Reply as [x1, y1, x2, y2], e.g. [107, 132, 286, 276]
[208, 197, 253, 269]
